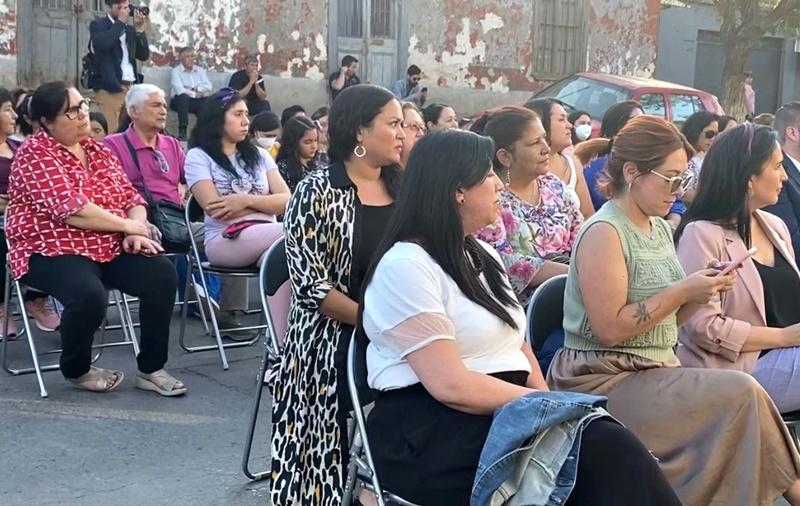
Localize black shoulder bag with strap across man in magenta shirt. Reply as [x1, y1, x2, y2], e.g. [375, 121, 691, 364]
[122, 132, 192, 253]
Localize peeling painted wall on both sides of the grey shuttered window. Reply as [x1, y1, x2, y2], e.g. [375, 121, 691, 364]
[408, 0, 660, 93]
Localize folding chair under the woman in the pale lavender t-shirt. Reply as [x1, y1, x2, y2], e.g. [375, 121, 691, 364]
[178, 194, 267, 371]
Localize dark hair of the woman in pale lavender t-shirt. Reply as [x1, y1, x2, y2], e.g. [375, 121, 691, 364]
[189, 88, 261, 179]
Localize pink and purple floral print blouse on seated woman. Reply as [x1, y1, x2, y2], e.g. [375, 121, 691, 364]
[475, 174, 583, 305]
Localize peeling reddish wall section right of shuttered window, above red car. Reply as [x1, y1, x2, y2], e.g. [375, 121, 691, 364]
[589, 0, 661, 77]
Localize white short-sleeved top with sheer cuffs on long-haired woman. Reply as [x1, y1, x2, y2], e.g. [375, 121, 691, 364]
[363, 242, 531, 390]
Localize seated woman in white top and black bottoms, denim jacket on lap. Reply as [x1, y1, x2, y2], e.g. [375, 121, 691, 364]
[358, 130, 680, 506]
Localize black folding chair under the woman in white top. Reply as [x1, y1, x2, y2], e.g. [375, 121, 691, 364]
[342, 336, 418, 506]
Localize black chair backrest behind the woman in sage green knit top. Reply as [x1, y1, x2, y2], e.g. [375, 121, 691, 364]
[526, 274, 567, 351]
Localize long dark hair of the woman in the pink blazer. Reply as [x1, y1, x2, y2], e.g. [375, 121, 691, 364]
[675, 123, 778, 248]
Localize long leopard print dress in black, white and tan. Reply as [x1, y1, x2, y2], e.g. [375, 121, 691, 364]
[269, 164, 357, 506]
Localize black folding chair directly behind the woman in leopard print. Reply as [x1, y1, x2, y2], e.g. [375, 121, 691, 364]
[242, 241, 289, 480]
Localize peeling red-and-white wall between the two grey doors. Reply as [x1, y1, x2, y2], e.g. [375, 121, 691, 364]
[148, 0, 328, 80]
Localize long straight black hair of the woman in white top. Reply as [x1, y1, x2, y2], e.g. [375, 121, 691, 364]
[360, 128, 521, 338]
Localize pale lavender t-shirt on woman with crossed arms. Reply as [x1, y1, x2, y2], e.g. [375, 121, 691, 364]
[184, 148, 278, 242]
